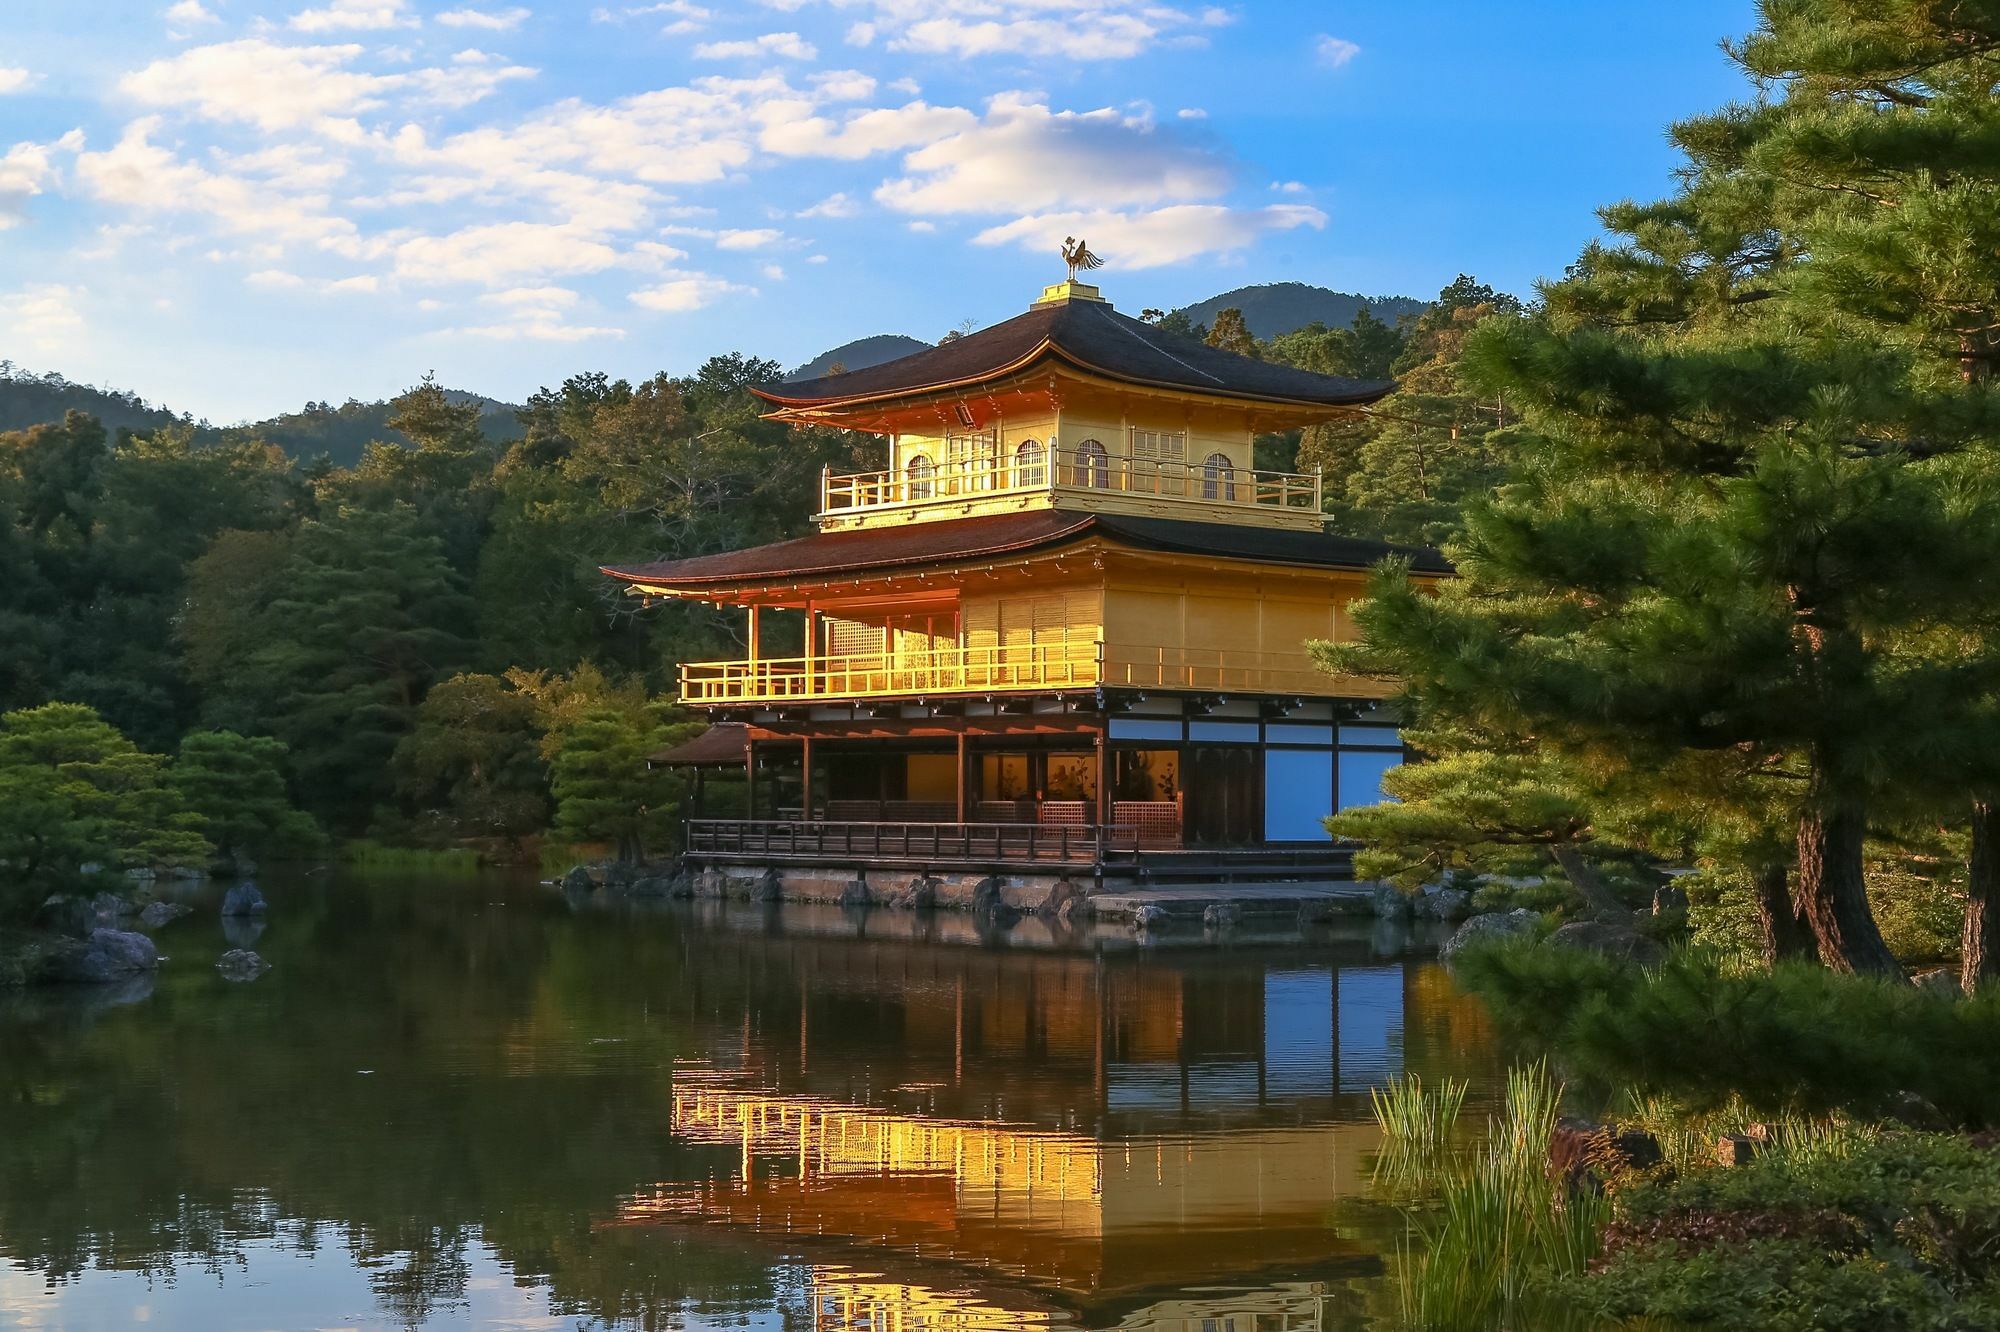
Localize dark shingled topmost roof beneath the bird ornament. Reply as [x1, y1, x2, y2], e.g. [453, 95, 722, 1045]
[752, 300, 1394, 406]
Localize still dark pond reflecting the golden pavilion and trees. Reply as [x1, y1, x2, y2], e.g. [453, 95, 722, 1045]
[0, 874, 1500, 1332]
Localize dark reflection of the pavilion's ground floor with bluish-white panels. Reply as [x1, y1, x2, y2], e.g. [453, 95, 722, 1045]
[664, 912, 1460, 1136]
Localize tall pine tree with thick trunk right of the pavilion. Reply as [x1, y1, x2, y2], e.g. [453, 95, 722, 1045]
[1320, 0, 2000, 974]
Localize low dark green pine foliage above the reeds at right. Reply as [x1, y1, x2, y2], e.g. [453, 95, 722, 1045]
[1456, 944, 2000, 1126]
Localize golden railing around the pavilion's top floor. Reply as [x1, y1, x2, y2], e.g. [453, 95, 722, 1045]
[820, 448, 1320, 516]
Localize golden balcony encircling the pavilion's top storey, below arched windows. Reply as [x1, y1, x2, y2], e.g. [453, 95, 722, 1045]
[818, 442, 1322, 530]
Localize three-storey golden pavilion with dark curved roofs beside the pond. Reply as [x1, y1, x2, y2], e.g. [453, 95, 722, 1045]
[606, 278, 1448, 874]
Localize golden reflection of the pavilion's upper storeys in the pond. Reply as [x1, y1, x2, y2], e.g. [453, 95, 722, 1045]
[620, 1080, 1376, 1328]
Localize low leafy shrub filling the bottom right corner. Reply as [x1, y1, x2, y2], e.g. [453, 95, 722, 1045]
[1566, 1134, 2000, 1332]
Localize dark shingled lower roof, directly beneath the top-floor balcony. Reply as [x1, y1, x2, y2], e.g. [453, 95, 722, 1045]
[604, 508, 1452, 588]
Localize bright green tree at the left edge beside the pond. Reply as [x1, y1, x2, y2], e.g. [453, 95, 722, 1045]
[0, 704, 210, 914]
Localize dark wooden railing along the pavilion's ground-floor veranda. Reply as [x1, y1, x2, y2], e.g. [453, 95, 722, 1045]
[688, 818, 1140, 864]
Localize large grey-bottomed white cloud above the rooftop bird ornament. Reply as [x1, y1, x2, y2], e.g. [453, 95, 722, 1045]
[876, 94, 1230, 214]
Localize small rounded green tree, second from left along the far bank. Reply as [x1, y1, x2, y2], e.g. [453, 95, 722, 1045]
[172, 730, 324, 860]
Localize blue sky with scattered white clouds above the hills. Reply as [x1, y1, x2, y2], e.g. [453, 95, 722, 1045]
[0, 0, 1752, 422]
